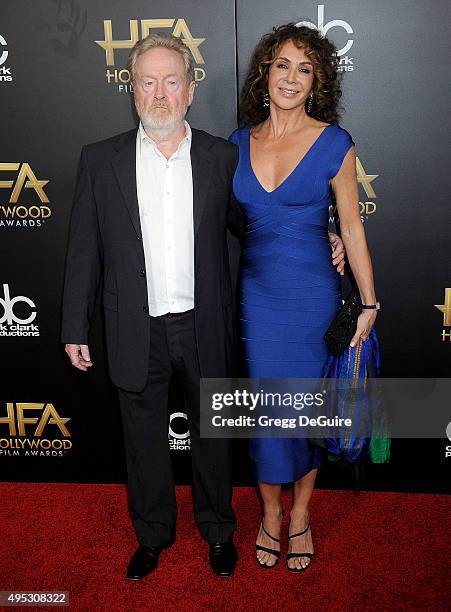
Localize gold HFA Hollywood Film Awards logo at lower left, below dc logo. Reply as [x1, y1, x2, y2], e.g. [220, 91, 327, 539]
[0, 402, 72, 457]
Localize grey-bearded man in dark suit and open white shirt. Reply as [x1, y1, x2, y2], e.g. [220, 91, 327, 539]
[62, 35, 241, 580]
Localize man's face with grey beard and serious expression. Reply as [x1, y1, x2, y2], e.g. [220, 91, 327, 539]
[134, 47, 195, 131]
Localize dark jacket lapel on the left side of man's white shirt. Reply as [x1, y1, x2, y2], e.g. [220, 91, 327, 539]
[111, 130, 142, 239]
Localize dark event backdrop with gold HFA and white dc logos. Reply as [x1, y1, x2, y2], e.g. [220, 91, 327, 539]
[0, 0, 451, 491]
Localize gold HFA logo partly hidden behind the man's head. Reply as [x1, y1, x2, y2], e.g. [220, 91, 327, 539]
[94, 19, 206, 92]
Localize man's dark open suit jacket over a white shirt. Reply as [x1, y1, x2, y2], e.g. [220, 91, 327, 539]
[61, 129, 243, 392]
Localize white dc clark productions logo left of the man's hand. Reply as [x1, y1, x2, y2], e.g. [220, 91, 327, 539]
[0, 284, 39, 337]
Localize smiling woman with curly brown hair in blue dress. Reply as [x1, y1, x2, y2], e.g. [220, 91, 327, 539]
[230, 24, 376, 571]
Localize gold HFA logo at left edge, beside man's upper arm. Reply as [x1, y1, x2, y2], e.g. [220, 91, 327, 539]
[0, 162, 52, 227]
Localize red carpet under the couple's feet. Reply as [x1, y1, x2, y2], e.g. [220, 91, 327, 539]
[0, 483, 451, 612]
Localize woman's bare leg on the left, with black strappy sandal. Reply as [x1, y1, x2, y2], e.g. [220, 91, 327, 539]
[256, 482, 282, 567]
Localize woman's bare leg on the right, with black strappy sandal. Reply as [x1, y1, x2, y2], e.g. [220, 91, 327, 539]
[288, 468, 318, 569]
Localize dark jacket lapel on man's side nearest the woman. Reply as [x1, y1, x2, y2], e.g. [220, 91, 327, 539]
[191, 129, 213, 235]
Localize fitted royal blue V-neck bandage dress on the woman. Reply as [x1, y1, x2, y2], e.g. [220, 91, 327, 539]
[230, 125, 354, 483]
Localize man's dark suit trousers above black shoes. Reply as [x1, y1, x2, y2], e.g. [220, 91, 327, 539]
[119, 310, 236, 546]
